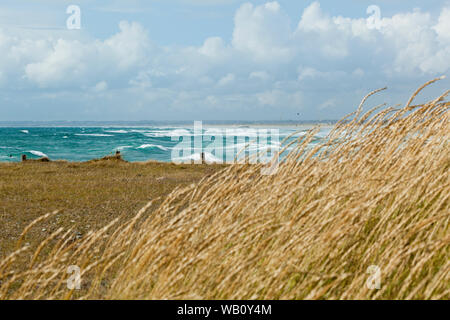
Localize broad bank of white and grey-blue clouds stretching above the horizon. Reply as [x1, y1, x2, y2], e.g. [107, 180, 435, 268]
[0, 2, 450, 120]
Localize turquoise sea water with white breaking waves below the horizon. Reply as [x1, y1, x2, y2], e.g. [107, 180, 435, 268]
[0, 125, 330, 162]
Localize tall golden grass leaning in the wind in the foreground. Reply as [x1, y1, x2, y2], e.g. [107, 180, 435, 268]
[0, 79, 450, 299]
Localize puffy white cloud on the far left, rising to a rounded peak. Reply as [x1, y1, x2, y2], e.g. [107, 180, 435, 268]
[22, 21, 151, 87]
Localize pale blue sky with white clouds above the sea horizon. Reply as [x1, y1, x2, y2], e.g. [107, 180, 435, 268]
[0, 0, 450, 121]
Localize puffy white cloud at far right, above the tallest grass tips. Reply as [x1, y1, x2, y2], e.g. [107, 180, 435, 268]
[296, 2, 450, 75]
